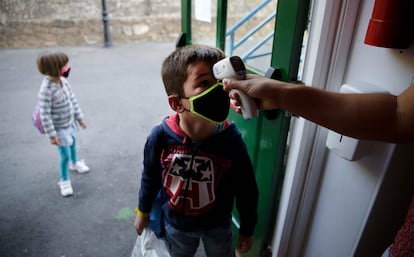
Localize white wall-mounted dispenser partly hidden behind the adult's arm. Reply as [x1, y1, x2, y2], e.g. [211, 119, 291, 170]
[326, 82, 389, 161]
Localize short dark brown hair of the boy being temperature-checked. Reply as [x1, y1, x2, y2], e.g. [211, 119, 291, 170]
[161, 45, 226, 96]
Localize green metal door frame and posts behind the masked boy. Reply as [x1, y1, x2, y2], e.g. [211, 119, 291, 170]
[181, 0, 310, 254]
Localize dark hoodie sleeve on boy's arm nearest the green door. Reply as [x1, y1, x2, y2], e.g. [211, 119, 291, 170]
[236, 138, 259, 236]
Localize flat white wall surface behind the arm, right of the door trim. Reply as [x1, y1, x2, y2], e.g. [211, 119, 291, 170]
[303, 0, 414, 257]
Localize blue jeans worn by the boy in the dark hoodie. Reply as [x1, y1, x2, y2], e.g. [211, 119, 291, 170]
[165, 220, 235, 257]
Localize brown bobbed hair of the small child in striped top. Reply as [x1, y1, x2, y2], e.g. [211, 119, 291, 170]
[36, 52, 69, 78]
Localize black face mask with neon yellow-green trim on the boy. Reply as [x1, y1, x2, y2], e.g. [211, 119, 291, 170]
[182, 82, 230, 123]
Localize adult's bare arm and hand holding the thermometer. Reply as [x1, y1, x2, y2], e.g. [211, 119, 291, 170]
[224, 76, 414, 143]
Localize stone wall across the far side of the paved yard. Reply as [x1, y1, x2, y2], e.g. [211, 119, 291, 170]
[0, 0, 275, 48]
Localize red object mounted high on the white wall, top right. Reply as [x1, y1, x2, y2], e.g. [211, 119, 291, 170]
[365, 0, 414, 49]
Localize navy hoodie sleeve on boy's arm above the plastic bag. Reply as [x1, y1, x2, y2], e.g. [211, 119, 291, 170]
[138, 126, 164, 213]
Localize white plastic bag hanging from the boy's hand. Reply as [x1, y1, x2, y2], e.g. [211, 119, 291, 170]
[131, 228, 206, 257]
